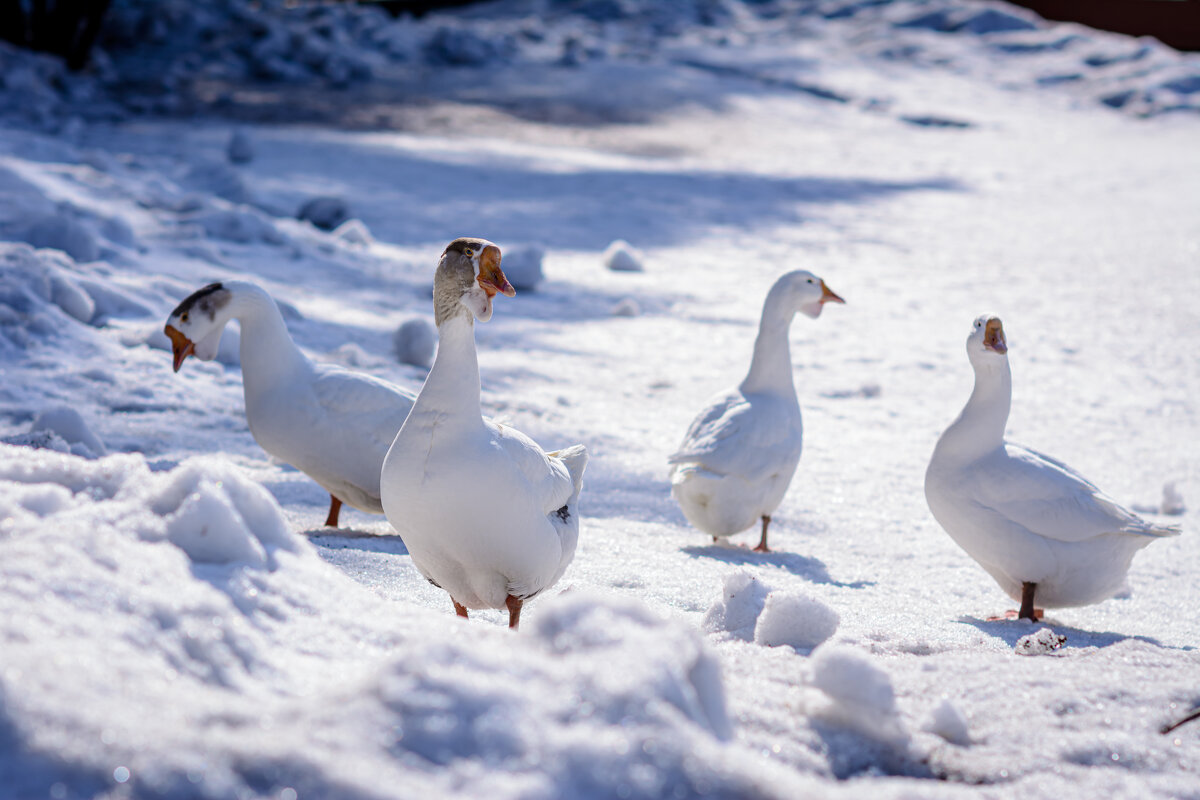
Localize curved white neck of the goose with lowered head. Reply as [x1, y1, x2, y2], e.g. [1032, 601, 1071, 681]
[228, 283, 311, 391]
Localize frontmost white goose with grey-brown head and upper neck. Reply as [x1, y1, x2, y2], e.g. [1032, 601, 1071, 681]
[382, 239, 588, 627]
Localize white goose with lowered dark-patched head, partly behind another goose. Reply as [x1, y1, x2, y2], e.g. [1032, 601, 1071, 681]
[166, 281, 415, 528]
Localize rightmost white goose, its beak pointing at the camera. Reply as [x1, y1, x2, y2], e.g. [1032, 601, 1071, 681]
[925, 314, 1180, 620]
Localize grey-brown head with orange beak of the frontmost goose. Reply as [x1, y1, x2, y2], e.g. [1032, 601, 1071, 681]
[433, 237, 517, 325]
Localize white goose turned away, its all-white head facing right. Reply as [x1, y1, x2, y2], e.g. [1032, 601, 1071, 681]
[667, 270, 845, 553]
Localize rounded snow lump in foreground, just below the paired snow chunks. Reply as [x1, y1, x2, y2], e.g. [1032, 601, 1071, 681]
[809, 644, 908, 746]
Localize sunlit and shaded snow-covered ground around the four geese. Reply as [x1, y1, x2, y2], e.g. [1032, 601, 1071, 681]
[0, 0, 1200, 799]
